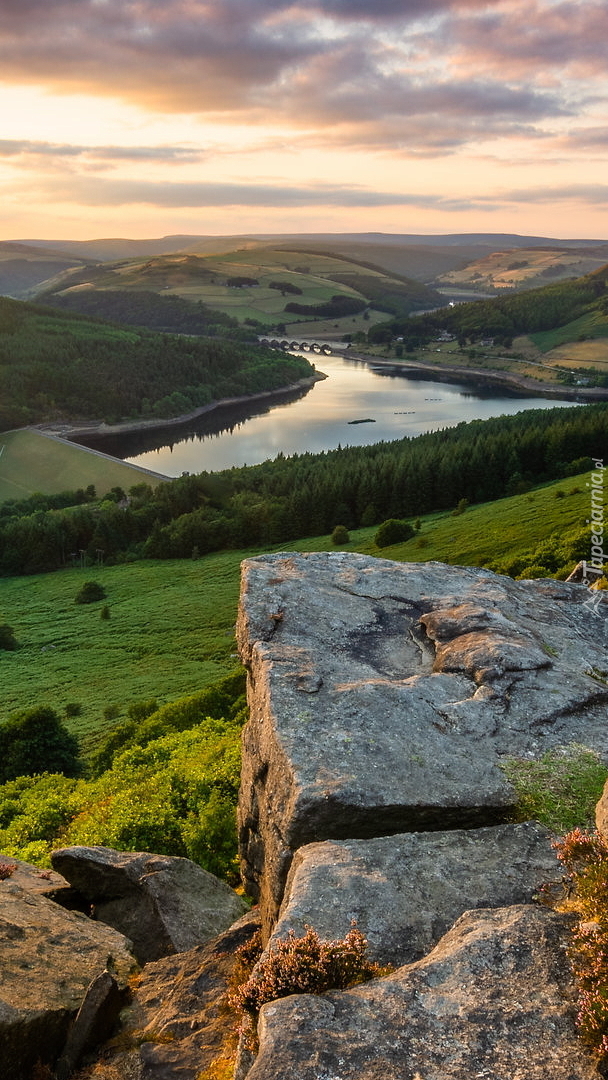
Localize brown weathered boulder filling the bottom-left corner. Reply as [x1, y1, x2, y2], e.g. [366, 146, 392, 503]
[0, 860, 136, 1080]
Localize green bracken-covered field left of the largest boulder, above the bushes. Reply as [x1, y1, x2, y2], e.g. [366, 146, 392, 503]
[0, 552, 240, 737]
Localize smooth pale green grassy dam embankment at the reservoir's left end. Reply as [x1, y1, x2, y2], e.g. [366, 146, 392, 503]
[0, 428, 163, 502]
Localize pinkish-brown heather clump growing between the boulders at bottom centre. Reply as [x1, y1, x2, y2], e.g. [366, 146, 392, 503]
[230, 924, 390, 1016]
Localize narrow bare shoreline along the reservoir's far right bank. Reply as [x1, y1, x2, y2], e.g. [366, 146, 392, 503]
[346, 350, 608, 404]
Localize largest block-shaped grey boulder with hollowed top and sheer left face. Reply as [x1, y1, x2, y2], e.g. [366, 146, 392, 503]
[238, 552, 608, 935]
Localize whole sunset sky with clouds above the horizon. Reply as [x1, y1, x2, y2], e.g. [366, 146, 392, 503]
[0, 0, 608, 240]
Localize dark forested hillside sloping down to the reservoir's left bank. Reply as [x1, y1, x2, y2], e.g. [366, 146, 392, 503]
[0, 297, 312, 431]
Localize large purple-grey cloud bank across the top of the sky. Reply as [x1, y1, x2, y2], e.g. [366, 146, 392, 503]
[0, 0, 608, 156]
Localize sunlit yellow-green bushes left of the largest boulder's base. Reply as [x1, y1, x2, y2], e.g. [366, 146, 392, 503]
[0, 720, 241, 885]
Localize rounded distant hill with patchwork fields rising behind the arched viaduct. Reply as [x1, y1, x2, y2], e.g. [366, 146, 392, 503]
[35, 245, 441, 337]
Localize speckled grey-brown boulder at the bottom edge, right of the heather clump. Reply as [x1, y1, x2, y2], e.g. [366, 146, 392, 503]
[247, 906, 598, 1080]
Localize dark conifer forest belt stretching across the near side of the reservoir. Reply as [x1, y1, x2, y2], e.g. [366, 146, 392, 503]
[0, 403, 608, 576]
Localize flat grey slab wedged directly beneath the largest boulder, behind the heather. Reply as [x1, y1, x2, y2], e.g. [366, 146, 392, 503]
[268, 822, 563, 967]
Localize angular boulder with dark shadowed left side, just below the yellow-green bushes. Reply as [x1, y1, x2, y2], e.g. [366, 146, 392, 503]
[51, 847, 247, 963]
